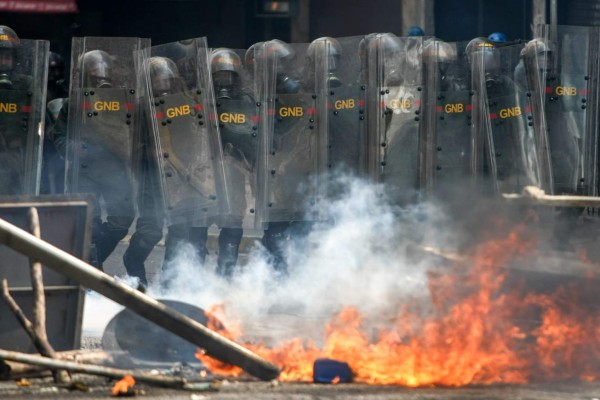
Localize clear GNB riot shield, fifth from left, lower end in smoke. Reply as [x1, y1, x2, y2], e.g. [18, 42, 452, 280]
[255, 40, 324, 222]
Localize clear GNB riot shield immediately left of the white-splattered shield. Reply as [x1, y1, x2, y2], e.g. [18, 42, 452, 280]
[307, 36, 367, 189]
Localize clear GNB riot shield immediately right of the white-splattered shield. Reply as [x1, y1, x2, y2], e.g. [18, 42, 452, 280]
[421, 39, 475, 198]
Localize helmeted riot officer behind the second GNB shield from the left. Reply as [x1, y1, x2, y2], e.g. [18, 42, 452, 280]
[51, 50, 134, 269]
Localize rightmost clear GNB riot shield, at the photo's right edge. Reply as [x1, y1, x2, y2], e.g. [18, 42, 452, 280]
[525, 26, 600, 196]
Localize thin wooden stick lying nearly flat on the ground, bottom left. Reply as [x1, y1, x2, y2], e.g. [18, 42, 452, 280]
[0, 349, 187, 388]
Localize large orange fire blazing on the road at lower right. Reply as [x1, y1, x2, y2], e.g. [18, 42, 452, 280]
[198, 226, 600, 387]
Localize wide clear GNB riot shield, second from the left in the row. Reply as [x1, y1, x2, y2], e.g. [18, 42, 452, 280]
[65, 37, 149, 219]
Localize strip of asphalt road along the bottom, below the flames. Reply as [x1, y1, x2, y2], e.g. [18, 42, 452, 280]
[0, 377, 600, 400]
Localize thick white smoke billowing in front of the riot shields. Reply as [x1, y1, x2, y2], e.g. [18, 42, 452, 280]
[144, 173, 460, 343]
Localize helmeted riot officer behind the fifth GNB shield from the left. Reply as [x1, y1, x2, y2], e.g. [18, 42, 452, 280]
[262, 40, 322, 273]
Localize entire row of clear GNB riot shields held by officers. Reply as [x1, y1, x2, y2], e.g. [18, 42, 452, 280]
[7, 26, 600, 276]
